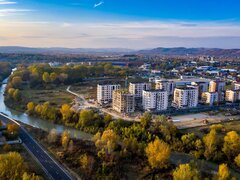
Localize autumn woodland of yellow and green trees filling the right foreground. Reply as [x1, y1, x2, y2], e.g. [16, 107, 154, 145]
[44, 110, 240, 180]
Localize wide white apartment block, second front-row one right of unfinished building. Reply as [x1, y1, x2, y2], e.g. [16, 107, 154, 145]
[173, 87, 198, 109]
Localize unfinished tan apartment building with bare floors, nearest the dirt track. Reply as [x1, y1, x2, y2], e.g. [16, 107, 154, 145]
[112, 90, 135, 114]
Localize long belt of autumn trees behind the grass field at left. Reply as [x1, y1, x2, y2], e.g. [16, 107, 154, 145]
[8, 63, 133, 89]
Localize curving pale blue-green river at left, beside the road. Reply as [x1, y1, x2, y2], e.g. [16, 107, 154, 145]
[0, 79, 92, 140]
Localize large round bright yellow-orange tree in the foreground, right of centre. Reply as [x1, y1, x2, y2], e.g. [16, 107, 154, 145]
[145, 138, 171, 169]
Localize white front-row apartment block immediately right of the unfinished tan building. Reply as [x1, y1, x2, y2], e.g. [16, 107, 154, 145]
[142, 90, 168, 111]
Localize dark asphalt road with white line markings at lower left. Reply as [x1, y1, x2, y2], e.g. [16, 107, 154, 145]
[0, 113, 73, 180]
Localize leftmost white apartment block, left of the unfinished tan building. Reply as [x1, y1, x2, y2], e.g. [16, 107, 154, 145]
[97, 84, 121, 104]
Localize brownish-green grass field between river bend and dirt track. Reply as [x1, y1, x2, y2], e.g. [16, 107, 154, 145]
[22, 86, 74, 107]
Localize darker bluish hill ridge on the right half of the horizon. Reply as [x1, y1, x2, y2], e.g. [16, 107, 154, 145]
[137, 47, 240, 57]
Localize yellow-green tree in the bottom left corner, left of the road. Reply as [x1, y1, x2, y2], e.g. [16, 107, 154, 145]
[0, 152, 26, 179]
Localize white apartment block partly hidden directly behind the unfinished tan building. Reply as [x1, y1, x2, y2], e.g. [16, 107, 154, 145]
[129, 83, 151, 98]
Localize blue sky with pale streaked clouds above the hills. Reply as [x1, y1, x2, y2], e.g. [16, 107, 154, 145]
[0, 0, 240, 49]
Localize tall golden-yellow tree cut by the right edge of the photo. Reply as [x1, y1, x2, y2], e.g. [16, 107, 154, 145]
[223, 131, 240, 160]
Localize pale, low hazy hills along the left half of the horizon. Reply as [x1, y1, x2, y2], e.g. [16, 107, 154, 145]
[0, 46, 134, 54]
